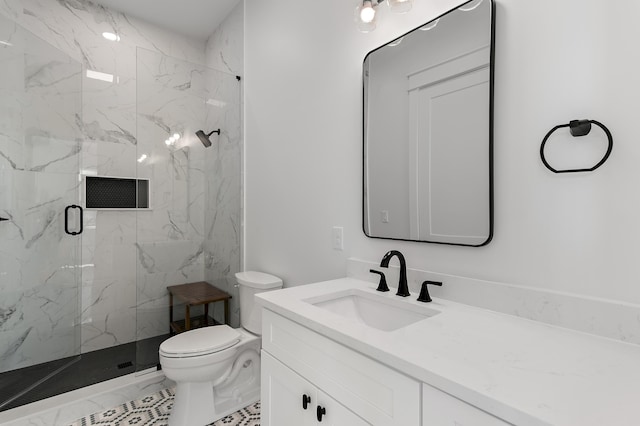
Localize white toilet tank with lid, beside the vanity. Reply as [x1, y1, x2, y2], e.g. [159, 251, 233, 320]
[236, 271, 282, 335]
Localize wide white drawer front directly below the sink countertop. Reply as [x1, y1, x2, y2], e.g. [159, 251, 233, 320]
[262, 309, 421, 426]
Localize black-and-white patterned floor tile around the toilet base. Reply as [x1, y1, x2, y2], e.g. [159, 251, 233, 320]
[69, 389, 260, 426]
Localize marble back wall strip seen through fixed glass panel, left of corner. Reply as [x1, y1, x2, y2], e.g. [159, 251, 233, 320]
[136, 49, 208, 339]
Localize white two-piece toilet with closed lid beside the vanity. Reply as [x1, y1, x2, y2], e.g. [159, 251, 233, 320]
[160, 271, 282, 426]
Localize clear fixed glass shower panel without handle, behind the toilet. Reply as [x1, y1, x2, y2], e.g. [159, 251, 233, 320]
[136, 48, 242, 370]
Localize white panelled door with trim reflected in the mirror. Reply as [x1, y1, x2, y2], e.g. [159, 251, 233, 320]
[408, 46, 490, 245]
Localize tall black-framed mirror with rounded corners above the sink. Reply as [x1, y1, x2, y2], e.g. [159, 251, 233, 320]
[363, 0, 494, 247]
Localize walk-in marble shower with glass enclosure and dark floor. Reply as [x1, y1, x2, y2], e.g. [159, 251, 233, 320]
[0, 17, 241, 411]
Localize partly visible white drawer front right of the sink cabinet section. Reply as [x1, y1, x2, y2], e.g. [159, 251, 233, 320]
[422, 383, 511, 426]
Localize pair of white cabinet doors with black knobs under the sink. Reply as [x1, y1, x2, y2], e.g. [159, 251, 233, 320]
[261, 351, 368, 426]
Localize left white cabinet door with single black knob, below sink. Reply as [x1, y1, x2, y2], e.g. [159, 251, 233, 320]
[260, 351, 317, 426]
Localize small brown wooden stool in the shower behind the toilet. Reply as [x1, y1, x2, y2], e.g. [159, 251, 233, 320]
[167, 281, 231, 333]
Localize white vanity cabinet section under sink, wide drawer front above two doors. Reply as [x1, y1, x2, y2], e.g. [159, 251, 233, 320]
[262, 309, 421, 426]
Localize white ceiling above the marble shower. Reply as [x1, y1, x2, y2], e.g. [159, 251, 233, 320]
[92, 0, 240, 40]
